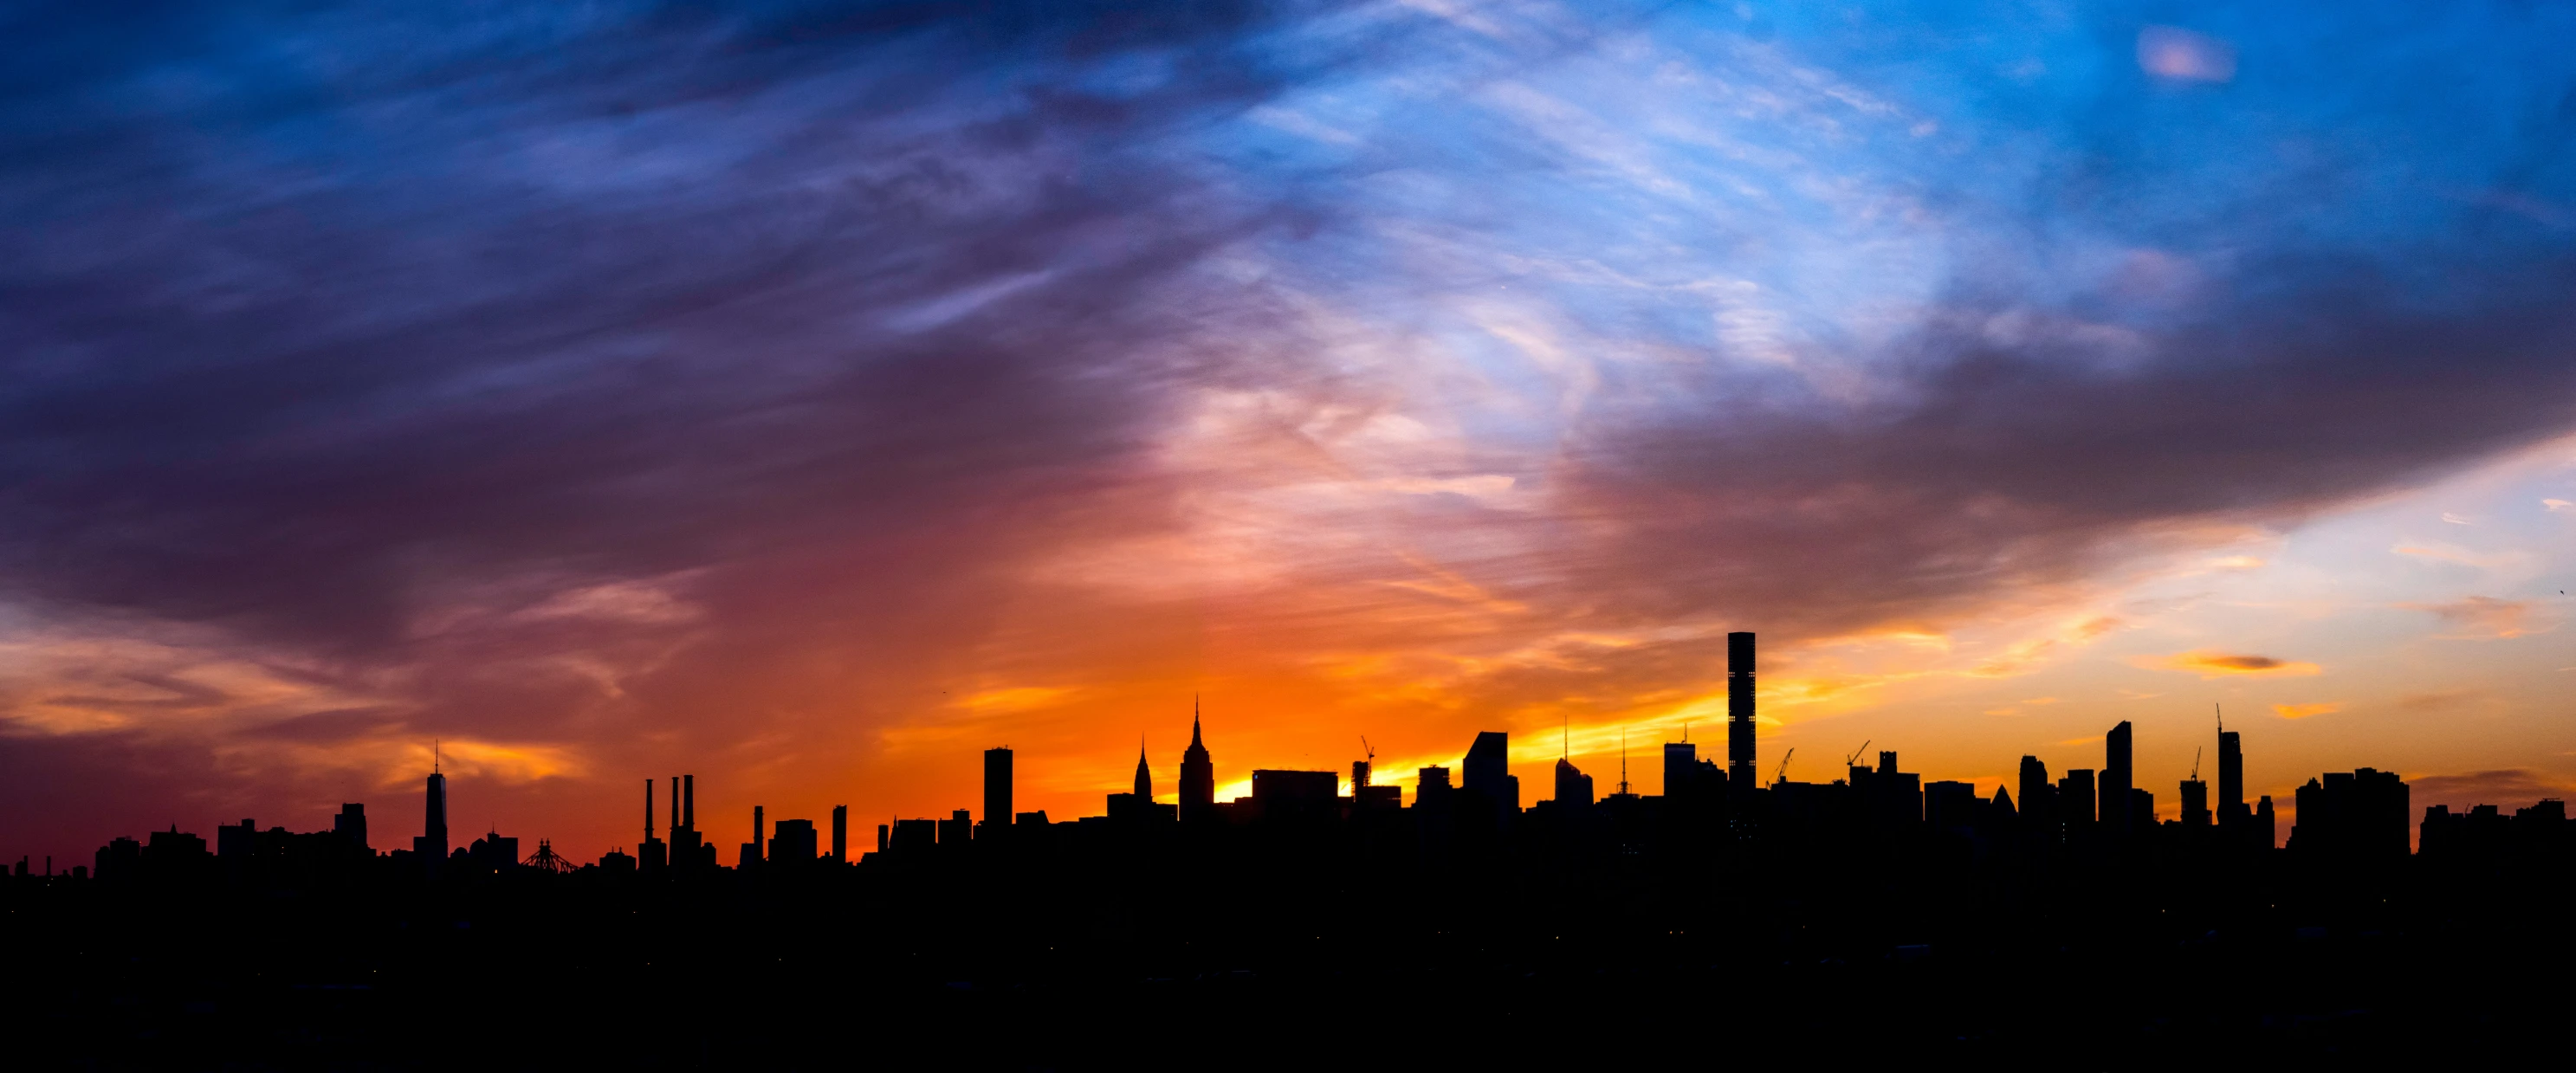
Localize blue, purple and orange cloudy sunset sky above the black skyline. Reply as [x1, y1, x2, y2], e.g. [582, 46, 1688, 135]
[0, 0, 2576, 864]
